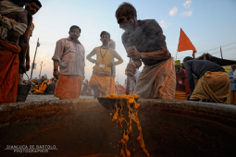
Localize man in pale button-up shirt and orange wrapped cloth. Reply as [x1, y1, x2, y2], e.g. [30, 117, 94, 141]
[52, 25, 85, 99]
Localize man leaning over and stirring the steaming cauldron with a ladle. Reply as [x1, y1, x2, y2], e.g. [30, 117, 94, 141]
[116, 2, 176, 99]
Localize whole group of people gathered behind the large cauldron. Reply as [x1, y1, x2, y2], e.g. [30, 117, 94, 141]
[0, 0, 236, 104]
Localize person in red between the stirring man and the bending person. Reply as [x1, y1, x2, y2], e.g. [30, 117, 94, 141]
[175, 60, 190, 101]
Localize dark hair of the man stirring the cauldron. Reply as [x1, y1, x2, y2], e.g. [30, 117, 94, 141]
[116, 2, 137, 18]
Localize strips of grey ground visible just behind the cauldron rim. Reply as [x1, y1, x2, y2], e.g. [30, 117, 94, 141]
[26, 94, 93, 102]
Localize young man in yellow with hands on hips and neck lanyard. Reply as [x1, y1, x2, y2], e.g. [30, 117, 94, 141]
[86, 31, 123, 98]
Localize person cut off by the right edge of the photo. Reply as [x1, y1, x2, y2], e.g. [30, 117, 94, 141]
[229, 64, 236, 105]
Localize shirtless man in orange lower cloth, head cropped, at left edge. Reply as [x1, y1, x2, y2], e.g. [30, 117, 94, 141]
[0, 0, 32, 104]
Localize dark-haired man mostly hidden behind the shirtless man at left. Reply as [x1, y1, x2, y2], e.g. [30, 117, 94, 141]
[19, 0, 42, 84]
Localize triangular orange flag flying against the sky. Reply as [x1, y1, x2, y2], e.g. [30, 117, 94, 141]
[177, 28, 197, 58]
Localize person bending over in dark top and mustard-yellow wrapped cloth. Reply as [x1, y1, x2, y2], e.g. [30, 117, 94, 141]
[183, 57, 230, 103]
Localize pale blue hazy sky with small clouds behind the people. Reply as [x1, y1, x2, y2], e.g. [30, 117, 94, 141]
[25, 0, 236, 84]
